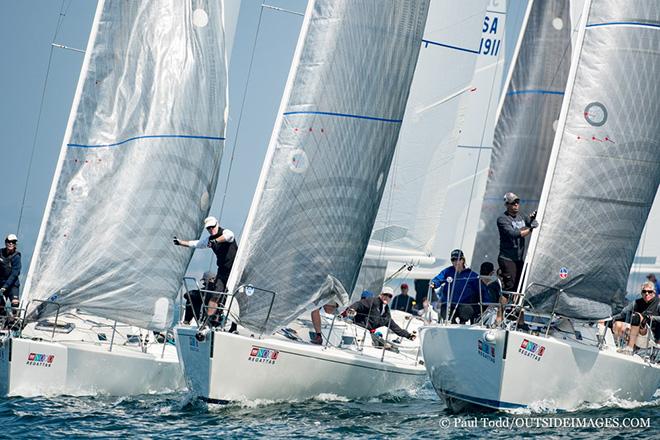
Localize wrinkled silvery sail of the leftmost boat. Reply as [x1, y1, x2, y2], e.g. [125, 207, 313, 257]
[24, 0, 227, 329]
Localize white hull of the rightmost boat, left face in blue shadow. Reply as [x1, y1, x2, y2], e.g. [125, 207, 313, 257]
[421, 325, 660, 410]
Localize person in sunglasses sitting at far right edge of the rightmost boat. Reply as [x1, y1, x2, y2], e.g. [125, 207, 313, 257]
[612, 281, 660, 354]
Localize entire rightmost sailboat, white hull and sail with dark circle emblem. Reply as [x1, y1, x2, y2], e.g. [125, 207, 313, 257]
[421, 0, 660, 409]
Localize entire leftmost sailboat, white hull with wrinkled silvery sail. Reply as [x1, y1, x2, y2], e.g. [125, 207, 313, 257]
[0, 0, 227, 395]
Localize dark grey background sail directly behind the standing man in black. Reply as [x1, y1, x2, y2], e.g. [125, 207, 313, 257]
[472, 0, 571, 267]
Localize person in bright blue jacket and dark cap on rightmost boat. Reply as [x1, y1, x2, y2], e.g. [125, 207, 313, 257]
[429, 249, 480, 323]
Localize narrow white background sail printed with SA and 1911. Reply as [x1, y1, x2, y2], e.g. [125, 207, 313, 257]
[428, 0, 510, 272]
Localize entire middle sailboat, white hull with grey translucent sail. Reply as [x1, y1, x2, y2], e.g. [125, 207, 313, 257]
[175, 0, 429, 402]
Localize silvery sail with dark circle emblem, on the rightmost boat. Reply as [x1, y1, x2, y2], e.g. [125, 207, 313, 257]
[527, 0, 660, 319]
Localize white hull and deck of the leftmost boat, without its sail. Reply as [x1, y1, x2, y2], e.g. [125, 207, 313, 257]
[0, 314, 185, 397]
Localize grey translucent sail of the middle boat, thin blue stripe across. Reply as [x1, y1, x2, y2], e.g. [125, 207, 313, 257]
[229, 0, 428, 333]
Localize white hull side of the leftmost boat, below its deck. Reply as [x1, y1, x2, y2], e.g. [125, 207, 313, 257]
[0, 337, 183, 397]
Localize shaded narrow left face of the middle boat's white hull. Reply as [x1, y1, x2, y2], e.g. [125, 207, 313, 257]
[174, 326, 213, 398]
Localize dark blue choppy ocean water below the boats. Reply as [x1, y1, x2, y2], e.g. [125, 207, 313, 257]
[0, 383, 660, 439]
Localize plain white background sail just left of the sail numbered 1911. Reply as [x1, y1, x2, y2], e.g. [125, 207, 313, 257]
[358, 0, 486, 283]
